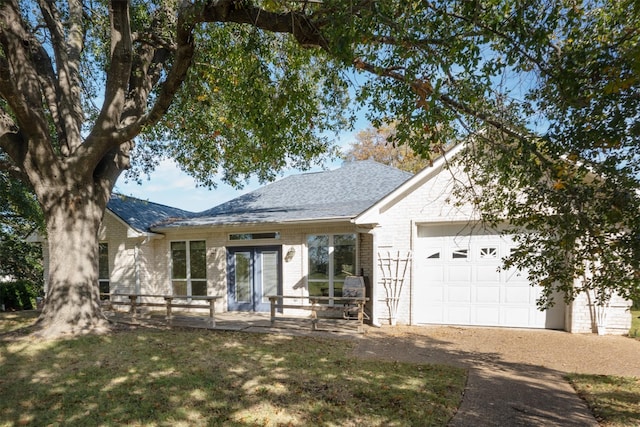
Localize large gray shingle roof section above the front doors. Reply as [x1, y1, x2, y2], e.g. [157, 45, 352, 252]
[153, 161, 412, 229]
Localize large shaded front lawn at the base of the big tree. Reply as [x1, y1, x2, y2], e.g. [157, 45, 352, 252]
[0, 314, 466, 427]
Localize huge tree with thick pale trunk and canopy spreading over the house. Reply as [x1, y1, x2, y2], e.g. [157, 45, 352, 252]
[0, 0, 640, 331]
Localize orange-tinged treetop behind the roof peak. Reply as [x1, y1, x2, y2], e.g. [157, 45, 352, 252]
[342, 125, 431, 173]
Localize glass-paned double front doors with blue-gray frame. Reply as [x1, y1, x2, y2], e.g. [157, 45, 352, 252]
[227, 246, 282, 311]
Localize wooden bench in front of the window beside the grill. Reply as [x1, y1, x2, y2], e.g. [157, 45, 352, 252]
[268, 295, 369, 332]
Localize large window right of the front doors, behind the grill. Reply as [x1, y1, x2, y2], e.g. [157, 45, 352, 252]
[307, 234, 356, 297]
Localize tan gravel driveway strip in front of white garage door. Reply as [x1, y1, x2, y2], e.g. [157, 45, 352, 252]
[355, 326, 640, 378]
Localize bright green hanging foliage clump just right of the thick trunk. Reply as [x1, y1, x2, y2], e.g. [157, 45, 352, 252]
[138, 25, 347, 186]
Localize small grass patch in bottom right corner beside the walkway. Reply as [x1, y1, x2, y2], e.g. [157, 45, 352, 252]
[569, 374, 640, 427]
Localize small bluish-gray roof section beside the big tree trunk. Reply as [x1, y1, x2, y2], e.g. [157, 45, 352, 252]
[107, 194, 195, 232]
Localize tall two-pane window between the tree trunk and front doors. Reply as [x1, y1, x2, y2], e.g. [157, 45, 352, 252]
[171, 240, 207, 296]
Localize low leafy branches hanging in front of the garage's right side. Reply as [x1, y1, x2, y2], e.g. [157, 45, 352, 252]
[457, 129, 640, 307]
